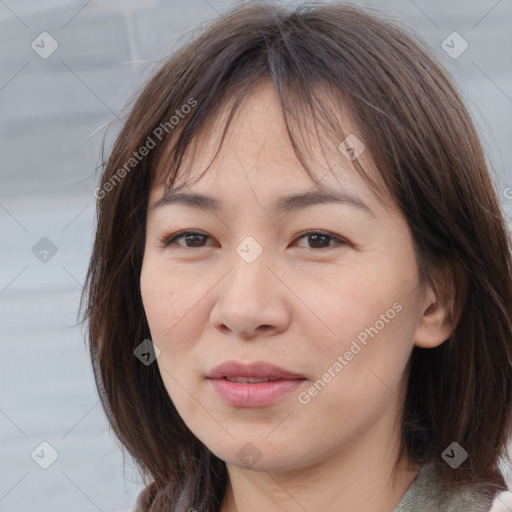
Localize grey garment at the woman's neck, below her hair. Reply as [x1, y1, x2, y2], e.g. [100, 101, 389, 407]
[393, 464, 492, 512]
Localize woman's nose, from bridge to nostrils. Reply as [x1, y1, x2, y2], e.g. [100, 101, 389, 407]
[210, 249, 291, 338]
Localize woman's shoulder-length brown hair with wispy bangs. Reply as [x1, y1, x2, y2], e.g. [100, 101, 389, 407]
[82, 3, 512, 512]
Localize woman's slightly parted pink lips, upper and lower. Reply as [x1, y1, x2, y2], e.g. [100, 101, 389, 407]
[208, 361, 306, 407]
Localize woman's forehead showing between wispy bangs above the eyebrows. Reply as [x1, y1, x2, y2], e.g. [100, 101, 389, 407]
[151, 80, 385, 207]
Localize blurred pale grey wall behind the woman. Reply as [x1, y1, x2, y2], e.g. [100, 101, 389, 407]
[0, 0, 512, 512]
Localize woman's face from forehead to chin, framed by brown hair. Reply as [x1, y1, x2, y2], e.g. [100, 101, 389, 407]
[141, 84, 436, 471]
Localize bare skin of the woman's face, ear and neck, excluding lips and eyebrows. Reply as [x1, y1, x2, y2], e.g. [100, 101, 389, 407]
[141, 82, 449, 512]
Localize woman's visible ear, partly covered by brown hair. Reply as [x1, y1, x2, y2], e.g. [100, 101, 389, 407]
[414, 272, 461, 348]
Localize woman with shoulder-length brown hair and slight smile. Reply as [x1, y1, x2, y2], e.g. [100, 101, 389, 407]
[80, 4, 512, 512]
